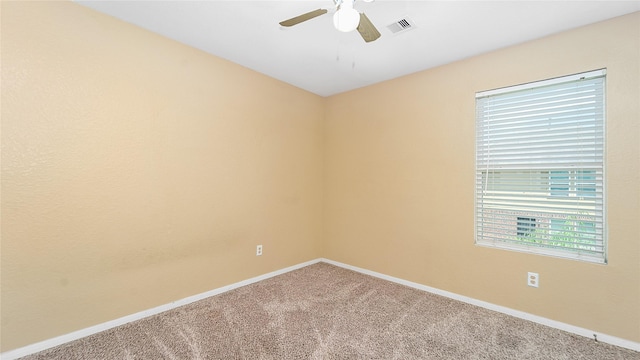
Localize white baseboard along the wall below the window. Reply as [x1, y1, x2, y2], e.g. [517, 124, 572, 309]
[321, 259, 640, 351]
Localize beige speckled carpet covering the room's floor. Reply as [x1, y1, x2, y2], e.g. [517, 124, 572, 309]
[17, 263, 640, 360]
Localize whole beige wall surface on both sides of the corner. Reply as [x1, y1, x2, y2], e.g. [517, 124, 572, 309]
[1, 2, 640, 351]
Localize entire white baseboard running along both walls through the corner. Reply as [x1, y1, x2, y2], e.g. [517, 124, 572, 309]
[0, 258, 640, 360]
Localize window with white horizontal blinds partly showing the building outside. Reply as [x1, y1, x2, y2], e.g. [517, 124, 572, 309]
[475, 70, 606, 263]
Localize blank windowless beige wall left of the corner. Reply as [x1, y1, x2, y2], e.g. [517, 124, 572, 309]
[2, 1, 326, 351]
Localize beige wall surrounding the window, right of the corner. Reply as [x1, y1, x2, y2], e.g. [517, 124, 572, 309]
[323, 13, 640, 342]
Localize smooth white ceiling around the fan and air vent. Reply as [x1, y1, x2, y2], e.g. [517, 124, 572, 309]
[76, 0, 640, 96]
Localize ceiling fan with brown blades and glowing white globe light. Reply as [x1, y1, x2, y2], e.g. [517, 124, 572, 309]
[280, 0, 380, 42]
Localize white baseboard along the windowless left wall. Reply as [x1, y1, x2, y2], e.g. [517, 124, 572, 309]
[0, 259, 321, 360]
